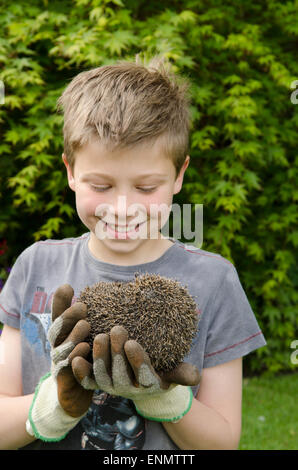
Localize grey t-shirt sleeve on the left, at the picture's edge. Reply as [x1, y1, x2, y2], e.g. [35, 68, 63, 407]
[0, 253, 25, 328]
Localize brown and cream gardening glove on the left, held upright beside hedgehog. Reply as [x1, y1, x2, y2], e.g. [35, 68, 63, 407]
[26, 284, 93, 441]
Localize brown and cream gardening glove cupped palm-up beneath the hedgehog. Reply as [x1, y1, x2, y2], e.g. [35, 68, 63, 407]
[73, 326, 200, 422]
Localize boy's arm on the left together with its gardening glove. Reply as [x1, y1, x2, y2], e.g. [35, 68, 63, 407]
[0, 285, 92, 449]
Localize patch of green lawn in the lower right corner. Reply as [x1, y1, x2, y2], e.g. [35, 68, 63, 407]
[239, 373, 298, 450]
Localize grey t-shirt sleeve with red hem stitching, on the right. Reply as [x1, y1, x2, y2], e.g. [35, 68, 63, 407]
[203, 264, 266, 367]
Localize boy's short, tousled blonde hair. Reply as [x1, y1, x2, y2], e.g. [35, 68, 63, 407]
[57, 56, 190, 174]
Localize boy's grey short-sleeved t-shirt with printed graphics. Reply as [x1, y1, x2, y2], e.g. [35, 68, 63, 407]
[0, 232, 266, 450]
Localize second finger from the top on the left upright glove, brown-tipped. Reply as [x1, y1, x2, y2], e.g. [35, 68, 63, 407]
[48, 302, 87, 347]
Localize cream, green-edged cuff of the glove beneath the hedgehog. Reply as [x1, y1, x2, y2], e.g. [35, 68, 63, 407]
[134, 385, 193, 422]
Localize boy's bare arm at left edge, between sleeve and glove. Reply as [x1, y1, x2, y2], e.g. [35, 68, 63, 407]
[0, 325, 35, 449]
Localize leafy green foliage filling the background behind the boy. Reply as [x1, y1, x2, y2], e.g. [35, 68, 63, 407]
[0, 0, 298, 372]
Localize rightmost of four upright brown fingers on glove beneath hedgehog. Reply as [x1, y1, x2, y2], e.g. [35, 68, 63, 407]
[124, 340, 161, 388]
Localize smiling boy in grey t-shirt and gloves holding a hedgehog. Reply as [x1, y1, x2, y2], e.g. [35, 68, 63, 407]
[0, 57, 265, 449]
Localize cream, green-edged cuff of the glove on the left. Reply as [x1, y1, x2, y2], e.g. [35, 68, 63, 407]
[28, 373, 84, 442]
